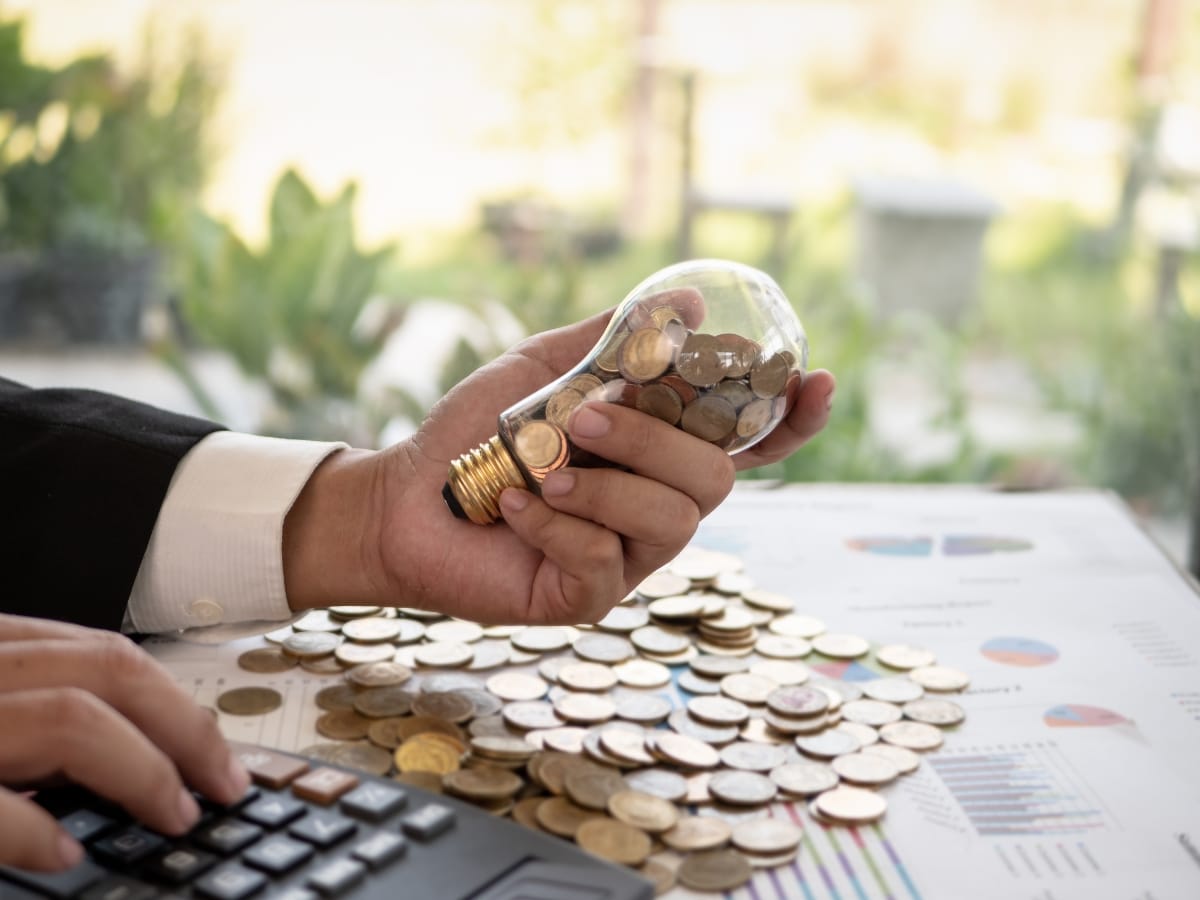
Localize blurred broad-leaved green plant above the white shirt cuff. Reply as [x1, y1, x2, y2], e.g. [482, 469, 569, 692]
[176, 170, 392, 437]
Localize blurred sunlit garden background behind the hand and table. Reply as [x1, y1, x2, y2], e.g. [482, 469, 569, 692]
[0, 0, 1200, 570]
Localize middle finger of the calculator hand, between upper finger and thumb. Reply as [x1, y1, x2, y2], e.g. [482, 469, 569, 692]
[0, 688, 199, 834]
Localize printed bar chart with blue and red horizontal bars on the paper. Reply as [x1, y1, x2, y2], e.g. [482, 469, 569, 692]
[926, 744, 1108, 836]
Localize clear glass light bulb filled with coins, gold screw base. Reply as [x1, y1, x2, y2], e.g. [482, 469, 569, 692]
[442, 259, 809, 524]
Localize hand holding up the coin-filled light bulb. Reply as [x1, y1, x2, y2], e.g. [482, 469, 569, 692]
[284, 313, 834, 623]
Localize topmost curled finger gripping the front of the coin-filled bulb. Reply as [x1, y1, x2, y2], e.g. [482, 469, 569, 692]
[569, 403, 734, 517]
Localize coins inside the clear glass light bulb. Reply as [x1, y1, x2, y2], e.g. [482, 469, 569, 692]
[510, 288, 799, 480]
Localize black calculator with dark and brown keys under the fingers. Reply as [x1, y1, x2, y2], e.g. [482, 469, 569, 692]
[0, 745, 654, 900]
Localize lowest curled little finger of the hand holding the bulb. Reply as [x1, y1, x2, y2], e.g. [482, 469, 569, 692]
[500, 488, 625, 624]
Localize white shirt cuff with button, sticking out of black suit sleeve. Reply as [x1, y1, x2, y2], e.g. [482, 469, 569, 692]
[126, 431, 348, 631]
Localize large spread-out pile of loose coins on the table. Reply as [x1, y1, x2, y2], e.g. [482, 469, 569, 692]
[229, 548, 968, 892]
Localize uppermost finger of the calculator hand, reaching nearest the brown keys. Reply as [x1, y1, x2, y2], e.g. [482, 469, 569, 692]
[0, 631, 248, 803]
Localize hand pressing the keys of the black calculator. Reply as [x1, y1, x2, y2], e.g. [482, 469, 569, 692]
[0, 616, 250, 870]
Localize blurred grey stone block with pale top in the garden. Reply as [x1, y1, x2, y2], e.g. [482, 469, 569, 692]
[853, 176, 1000, 325]
